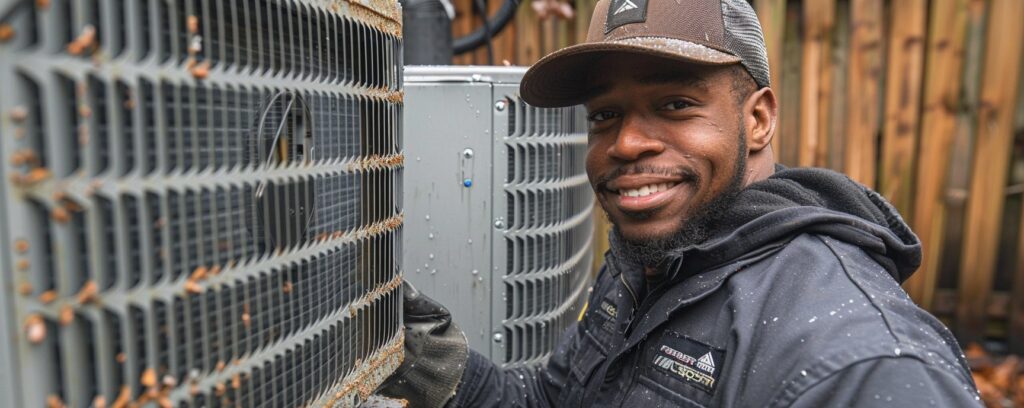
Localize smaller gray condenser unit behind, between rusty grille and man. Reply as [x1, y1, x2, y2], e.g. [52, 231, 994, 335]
[403, 67, 593, 366]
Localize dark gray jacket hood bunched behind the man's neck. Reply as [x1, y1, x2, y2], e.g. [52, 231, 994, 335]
[611, 165, 922, 283]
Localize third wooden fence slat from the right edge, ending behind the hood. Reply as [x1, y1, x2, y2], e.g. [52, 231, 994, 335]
[879, 0, 928, 219]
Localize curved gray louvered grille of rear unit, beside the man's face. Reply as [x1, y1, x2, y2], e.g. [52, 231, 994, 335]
[503, 98, 594, 366]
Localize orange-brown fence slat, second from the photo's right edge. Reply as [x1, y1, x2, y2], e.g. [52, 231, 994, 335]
[905, 0, 968, 308]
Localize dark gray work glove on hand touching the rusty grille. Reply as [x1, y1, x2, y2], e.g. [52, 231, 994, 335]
[379, 282, 469, 408]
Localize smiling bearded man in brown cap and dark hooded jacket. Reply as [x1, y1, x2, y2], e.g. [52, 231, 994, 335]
[384, 0, 980, 407]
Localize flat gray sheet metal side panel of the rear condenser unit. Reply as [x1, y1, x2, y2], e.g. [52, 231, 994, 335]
[403, 72, 493, 354]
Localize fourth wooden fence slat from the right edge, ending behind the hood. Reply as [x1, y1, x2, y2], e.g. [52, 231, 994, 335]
[845, 0, 882, 187]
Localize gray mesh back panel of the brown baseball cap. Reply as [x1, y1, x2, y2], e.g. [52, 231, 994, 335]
[722, 0, 770, 87]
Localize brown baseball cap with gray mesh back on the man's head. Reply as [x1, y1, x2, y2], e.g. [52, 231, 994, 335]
[519, 0, 769, 108]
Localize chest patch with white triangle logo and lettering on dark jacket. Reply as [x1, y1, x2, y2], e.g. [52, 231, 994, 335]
[651, 333, 725, 395]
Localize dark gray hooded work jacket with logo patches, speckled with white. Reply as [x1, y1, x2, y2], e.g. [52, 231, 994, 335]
[449, 167, 980, 407]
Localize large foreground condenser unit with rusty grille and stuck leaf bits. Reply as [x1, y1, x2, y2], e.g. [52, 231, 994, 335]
[0, 0, 403, 407]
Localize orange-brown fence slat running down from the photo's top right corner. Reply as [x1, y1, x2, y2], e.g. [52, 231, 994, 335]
[955, 0, 1024, 341]
